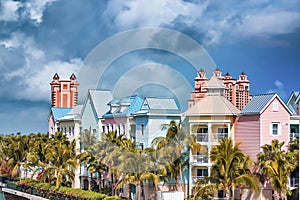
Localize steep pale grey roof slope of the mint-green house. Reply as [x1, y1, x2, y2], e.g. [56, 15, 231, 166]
[85, 90, 113, 118]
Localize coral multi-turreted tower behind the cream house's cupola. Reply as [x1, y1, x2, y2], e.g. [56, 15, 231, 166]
[188, 68, 251, 110]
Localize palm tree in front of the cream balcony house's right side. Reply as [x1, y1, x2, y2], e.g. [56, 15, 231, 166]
[210, 138, 259, 199]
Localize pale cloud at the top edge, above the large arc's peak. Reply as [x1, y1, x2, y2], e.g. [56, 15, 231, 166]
[105, 0, 208, 30]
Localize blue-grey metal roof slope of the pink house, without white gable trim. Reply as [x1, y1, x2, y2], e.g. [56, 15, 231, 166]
[241, 93, 276, 114]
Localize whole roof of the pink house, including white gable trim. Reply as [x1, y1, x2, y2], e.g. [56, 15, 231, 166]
[241, 93, 292, 115]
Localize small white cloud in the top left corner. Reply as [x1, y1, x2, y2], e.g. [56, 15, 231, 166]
[0, 0, 22, 21]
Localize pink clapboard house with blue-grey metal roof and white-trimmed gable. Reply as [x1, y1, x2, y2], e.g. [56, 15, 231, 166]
[234, 94, 292, 160]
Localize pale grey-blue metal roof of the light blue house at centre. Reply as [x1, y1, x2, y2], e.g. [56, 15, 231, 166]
[135, 97, 181, 115]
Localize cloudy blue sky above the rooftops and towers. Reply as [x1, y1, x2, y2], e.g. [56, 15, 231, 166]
[0, 0, 300, 134]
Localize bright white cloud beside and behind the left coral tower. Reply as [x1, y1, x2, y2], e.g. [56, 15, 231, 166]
[0, 33, 82, 101]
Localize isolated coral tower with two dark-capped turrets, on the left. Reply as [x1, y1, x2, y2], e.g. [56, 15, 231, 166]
[50, 73, 79, 108]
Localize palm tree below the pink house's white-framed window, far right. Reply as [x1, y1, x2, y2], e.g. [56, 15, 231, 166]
[257, 140, 298, 199]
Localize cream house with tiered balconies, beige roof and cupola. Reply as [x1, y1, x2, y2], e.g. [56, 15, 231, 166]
[183, 76, 240, 194]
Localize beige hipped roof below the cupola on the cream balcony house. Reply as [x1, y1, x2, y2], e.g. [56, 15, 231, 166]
[184, 94, 240, 116]
